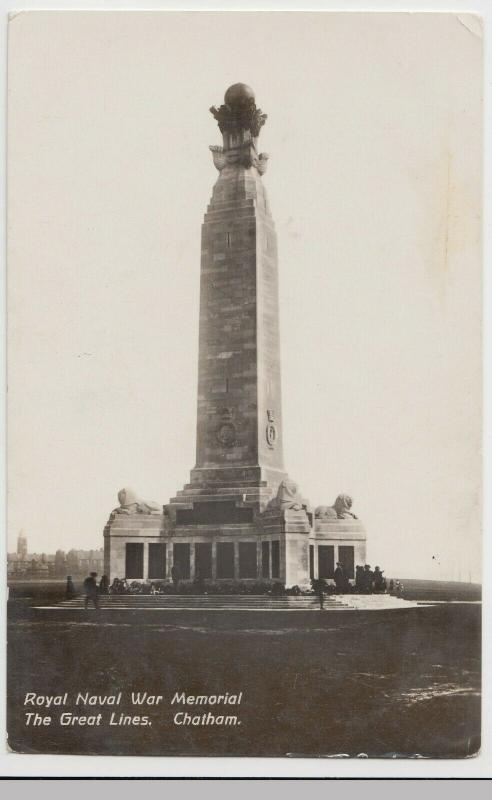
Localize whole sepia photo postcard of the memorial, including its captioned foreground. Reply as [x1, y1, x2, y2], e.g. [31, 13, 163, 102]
[8, 12, 482, 758]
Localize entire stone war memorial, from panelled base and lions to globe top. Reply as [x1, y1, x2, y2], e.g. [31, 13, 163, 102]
[104, 83, 366, 586]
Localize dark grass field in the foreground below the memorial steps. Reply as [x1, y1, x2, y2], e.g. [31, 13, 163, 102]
[8, 582, 480, 758]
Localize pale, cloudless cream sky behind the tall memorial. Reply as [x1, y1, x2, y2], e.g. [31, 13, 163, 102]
[8, 12, 482, 580]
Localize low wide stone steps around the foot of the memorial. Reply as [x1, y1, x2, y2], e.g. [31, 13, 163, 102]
[38, 594, 421, 612]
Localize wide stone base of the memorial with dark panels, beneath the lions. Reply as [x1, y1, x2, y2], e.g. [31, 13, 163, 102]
[104, 504, 366, 589]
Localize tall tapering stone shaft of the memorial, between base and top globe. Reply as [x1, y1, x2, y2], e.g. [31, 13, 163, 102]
[192, 84, 283, 484]
